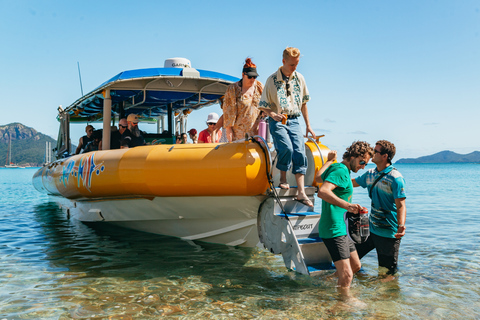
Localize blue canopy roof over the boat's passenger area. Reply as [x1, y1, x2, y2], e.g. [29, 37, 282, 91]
[65, 66, 239, 122]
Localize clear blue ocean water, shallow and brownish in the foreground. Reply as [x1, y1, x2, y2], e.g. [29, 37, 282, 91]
[0, 164, 480, 320]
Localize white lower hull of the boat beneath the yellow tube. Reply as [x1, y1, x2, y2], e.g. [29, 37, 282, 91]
[55, 192, 266, 247]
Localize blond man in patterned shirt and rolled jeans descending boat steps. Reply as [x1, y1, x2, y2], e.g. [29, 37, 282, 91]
[259, 47, 315, 207]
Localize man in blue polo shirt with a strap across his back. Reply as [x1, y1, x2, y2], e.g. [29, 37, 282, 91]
[352, 140, 407, 275]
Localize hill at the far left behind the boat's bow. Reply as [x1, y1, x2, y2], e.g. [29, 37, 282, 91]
[0, 122, 56, 166]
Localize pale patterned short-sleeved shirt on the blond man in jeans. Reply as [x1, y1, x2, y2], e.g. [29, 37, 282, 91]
[259, 67, 310, 116]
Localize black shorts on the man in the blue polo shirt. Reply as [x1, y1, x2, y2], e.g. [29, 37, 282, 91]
[355, 233, 401, 274]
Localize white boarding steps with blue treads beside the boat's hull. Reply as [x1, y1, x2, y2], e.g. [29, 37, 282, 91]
[257, 187, 333, 275]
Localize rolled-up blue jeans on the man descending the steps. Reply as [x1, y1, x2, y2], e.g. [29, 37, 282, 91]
[268, 118, 307, 175]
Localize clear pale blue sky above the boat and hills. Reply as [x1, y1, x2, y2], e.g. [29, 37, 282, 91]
[0, 0, 480, 159]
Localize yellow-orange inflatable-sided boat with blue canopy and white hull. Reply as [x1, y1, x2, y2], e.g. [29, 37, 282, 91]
[33, 60, 328, 251]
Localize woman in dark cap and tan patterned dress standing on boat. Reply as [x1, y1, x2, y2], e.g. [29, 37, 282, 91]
[222, 58, 263, 142]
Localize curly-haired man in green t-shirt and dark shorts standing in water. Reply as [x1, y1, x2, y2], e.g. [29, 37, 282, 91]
[316, 141, 373, 295]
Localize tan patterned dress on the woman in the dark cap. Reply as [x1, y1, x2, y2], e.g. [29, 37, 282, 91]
[223, 80, 263, 141]
